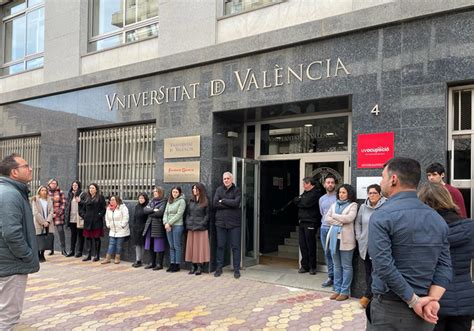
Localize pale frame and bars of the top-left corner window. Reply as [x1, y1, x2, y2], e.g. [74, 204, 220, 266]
[0, 0, 45, 77]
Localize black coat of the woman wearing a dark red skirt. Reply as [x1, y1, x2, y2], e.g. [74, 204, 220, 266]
[79, 194, 106, 230]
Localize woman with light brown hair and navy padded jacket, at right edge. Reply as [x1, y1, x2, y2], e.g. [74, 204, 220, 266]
[418, 182, 474, 331]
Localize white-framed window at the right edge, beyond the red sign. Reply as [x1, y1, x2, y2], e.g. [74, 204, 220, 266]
[449, 86, 474, 216]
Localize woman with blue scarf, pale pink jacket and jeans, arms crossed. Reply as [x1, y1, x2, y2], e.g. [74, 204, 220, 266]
[326, 184, 357, 301]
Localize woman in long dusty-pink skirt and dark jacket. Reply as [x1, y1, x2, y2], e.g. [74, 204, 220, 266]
[185, 183, 210, 276]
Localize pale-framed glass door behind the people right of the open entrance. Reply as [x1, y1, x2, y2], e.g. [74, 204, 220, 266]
[300, 156, 350, 272]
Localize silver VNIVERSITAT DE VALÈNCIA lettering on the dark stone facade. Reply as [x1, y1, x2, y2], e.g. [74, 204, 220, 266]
[105, 58, 350, 111]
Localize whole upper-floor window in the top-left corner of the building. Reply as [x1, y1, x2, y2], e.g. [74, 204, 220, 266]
[1, 0, 44, 75]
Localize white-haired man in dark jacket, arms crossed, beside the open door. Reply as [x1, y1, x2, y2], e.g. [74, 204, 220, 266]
[213, 172, 242, 279]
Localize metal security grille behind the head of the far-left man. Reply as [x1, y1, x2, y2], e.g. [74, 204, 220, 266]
[0, 136, 41, 194]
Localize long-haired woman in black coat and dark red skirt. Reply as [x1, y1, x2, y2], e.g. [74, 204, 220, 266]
[79, 183, 106, 262]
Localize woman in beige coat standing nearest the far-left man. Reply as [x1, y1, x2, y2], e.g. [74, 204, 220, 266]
[31, 185, 54, 262]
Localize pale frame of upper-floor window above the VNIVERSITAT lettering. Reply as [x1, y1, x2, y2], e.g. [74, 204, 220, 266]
[87, 0, 160, 54]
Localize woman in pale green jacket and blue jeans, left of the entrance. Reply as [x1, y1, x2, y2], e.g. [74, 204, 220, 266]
[163, 186, 186, 272]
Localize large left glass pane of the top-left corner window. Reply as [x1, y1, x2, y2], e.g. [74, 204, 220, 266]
[5, 16, 26, 63]
